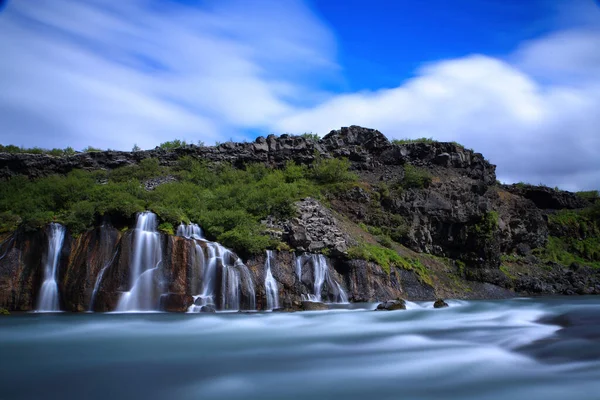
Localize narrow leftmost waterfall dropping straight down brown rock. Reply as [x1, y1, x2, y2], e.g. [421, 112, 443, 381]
[36, 223, 65, 312]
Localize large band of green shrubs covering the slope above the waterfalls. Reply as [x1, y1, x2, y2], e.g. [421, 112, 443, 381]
[0, 157, 357, 254]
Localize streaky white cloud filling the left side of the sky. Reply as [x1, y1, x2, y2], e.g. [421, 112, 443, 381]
[0, 0, 337, 149]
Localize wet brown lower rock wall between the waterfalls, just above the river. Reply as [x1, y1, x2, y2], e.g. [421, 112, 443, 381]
[0, 224, 434, 312]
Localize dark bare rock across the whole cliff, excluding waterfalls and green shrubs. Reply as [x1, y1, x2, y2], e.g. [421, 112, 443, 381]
[0, 126, 600, 311]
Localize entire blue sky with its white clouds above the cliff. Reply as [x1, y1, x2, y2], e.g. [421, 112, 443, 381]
[0, 0, 600, 190]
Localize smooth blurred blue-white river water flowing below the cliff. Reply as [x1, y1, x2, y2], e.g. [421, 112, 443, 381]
[0, 297, 600, 400]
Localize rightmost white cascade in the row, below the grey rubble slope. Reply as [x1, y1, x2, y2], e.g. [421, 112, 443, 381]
[295, 254, 348, 303]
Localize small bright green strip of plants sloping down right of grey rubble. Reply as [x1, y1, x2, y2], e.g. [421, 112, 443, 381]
[348, 243, 433, 286]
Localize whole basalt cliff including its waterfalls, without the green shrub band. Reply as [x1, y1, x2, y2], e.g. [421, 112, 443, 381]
[0, 126, 600, 311]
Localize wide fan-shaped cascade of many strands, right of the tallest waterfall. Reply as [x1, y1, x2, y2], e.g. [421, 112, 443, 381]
[177, 224, 256, 312]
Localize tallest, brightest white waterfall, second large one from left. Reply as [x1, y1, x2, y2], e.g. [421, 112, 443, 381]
[116, 212, 162, 311]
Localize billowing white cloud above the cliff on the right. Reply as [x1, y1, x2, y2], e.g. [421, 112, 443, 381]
[277, 31, 600, 190]
